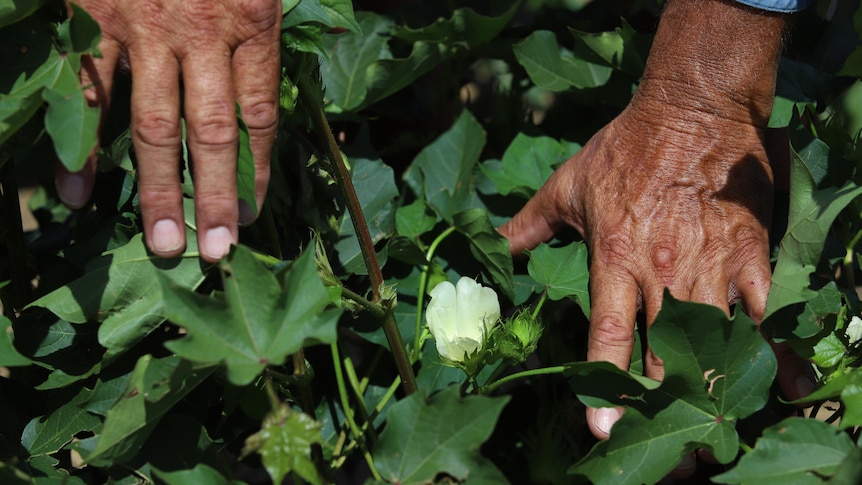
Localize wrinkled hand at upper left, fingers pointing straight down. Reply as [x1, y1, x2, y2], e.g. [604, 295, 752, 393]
[56, 0, 281, 261]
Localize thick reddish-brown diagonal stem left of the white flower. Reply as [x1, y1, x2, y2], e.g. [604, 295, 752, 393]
[297, 71, 417, 395]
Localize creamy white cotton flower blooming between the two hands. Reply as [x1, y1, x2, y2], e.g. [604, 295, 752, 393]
[425, 277, 500, 362]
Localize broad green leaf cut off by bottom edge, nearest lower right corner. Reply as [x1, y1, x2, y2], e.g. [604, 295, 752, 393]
[712, 418, 854, 485]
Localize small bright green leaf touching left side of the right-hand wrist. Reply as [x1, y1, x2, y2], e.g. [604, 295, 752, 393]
[569, 19, 650, 77]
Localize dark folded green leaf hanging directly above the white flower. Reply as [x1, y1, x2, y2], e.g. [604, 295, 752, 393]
[452, 209, 515, 300]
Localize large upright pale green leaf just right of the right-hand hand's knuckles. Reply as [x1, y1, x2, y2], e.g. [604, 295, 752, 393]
[764, 146, 862, 320]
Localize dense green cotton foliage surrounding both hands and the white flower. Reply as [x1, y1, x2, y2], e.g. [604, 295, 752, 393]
[0, 0, 862, 485]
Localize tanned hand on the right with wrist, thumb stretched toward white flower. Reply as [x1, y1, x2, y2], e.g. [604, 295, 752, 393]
[500, 0, 813, 439]
